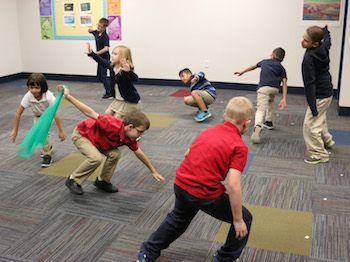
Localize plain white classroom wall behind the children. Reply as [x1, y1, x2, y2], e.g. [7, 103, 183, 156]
[0, 0, 344, 91]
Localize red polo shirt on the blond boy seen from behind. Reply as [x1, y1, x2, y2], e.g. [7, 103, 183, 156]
[175, 121, 248, 199]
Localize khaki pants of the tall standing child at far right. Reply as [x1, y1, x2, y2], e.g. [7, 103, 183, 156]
[303, 96, 332, 160]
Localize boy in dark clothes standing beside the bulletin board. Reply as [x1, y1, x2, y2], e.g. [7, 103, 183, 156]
[88, 18, 114, 99]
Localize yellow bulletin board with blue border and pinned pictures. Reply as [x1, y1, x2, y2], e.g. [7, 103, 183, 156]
[52, 0, 106, 39]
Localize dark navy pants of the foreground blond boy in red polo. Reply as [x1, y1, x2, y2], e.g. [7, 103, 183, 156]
[141, 185, 253, 262]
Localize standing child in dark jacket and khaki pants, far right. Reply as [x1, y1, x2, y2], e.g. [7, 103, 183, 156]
[301, 26, 335, 164]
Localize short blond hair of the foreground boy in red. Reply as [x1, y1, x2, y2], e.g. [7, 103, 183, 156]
[225, 96, 255, 124]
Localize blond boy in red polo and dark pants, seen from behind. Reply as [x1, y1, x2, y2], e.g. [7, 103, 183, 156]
[137, 97, 254, 262]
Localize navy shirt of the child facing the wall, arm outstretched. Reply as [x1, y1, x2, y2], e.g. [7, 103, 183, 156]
[256, 58, 287, 89]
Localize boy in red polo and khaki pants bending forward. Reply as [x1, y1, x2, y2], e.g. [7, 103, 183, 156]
[57, 85, 164, 195]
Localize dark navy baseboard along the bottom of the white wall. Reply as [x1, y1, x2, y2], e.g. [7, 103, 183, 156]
[0, 72, 338, 97]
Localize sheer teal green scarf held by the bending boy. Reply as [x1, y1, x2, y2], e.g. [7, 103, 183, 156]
[16, 88, 64, 159]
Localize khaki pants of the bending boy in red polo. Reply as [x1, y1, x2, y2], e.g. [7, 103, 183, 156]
[72, 128, 120, 185]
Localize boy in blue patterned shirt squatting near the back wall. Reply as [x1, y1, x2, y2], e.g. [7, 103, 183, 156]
[179, 68, 216, 122]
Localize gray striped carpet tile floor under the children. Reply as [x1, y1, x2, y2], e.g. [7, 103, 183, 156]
[0, 79, 350, 262]
